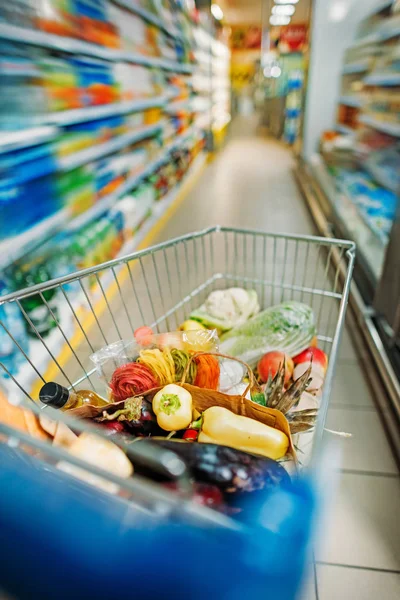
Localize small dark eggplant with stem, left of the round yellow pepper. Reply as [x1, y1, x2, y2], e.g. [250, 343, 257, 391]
[98, 397, 165, 436]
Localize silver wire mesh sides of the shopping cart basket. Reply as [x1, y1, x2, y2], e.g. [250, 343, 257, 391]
[0, 227, 355, 510]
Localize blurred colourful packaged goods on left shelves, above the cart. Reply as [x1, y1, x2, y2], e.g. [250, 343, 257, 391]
[0, 0, 225, 296]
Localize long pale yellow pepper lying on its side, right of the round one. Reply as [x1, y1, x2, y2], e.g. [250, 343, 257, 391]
[198, 406, 289, 459]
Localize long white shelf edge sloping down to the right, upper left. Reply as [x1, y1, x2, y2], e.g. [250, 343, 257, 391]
[0, 23, 192, 73]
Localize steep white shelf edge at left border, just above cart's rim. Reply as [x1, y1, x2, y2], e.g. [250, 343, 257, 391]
[0, 208, 70, 269]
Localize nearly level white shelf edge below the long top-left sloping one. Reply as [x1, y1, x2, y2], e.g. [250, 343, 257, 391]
[45, 95, 169, 125]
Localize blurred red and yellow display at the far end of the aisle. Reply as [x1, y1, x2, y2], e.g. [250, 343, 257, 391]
[232, 17, 308, 145]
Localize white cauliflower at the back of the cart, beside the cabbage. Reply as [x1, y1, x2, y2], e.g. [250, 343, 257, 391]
[190, 288, 260, 331]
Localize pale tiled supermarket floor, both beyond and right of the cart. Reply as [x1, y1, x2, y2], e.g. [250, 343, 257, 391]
[157, 118, 400, 600]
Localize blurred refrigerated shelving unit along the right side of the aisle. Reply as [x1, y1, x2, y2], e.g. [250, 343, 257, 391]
[297, 0, 400, 460]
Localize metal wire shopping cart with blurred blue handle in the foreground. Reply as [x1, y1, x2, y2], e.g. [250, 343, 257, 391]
[0, 227, 355, 600]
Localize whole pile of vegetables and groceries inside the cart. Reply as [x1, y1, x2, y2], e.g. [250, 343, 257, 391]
[8, 288, 328, 514]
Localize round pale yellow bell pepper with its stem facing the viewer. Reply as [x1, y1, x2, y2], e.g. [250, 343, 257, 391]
[153, 383, 192, 431]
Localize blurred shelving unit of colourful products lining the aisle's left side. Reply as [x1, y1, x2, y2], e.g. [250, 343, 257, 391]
[0, 0, 230, 387]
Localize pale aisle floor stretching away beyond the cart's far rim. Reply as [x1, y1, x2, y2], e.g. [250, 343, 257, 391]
[158, 117, 312, 241]
